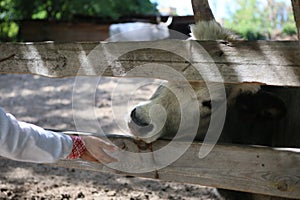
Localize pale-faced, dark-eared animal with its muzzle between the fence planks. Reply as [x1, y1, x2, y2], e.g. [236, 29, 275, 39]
[128, 14, 286, 144]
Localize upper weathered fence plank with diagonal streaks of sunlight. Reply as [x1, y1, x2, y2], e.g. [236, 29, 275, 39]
[0, 40, 300, 86]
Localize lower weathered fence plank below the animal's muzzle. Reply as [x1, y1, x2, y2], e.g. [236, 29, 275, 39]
[56, 136, 300, 199]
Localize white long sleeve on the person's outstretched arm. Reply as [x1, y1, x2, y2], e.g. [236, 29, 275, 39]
[0, 108, 73, 163]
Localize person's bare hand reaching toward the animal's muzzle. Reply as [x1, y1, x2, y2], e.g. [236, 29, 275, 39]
[80, 136, 118, 164]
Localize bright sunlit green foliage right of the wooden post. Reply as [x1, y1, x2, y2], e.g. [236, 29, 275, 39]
[225, 0, 296, 40]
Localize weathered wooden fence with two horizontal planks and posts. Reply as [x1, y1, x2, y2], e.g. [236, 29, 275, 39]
[0, 0, 300, 199]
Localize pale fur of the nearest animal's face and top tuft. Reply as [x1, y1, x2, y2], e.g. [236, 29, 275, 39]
[128, 21, 260, 143]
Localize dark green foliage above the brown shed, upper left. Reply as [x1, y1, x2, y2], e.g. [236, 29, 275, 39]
[0, 0, 157, 41]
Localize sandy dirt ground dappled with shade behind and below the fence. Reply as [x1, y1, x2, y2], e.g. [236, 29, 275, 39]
[0, 75, 219, 200]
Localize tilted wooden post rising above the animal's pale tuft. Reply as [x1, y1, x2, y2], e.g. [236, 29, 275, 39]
[192, 0, 215, 23]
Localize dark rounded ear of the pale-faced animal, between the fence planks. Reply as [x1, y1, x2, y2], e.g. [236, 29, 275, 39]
[235, 90, 287, 121]
